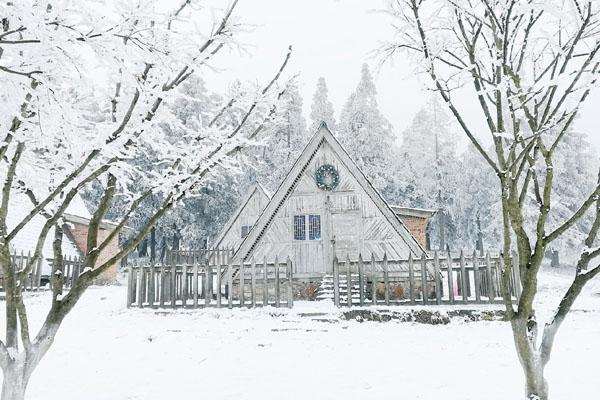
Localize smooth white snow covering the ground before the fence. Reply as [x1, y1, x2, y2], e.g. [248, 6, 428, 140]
[0, 273, 600, 400]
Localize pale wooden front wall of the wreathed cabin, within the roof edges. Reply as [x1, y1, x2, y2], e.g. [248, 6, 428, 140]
[248, 141, 418, 273]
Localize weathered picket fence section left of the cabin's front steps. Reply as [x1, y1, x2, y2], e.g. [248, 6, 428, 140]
[127, 253, 294, 308]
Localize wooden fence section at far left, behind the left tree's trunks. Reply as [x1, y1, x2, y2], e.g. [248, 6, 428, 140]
[0, 251, 83, 291]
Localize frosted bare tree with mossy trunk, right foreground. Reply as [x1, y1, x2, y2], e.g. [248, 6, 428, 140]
[381, 0, 600, 399]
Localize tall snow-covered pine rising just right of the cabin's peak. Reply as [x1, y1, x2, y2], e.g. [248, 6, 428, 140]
[337, 64, 395, 197]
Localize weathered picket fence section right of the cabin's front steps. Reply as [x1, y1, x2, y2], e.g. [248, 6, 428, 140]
[333, 252, 522, 306]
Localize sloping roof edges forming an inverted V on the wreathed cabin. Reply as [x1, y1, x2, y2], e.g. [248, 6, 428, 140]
[234, 122, 425, 260]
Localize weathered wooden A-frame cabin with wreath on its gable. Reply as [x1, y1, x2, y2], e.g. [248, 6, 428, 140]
[234, 123, 425, 274]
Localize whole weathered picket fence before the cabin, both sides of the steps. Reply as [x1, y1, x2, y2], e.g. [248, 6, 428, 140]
[127, 250, 521, 308]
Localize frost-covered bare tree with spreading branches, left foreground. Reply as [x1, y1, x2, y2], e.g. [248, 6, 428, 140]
[0, 0, 291, 400]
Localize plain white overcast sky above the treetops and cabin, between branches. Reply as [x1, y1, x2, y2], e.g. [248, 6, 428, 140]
[209, 0, 600, 149]
